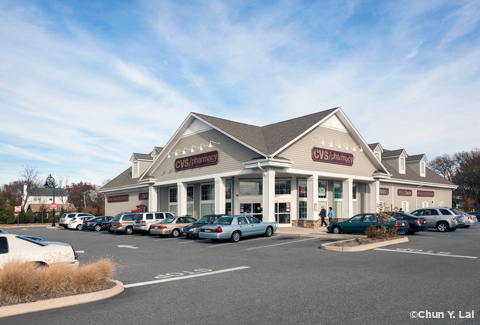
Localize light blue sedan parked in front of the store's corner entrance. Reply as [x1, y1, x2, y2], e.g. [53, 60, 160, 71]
[198, 215, 277, 242]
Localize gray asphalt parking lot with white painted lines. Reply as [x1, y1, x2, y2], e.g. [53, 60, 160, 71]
[2, 226, 480, 324]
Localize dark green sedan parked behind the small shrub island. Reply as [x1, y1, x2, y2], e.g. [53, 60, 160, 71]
[327, 213, 410, 235]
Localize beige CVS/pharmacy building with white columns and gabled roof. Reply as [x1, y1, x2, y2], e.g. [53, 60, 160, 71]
[101, 108, 456, 227]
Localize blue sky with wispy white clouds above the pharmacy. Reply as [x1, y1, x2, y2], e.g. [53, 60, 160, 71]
[0, 0, 480, 185]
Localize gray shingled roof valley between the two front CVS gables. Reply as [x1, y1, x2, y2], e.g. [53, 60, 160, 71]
[194, 108, 336, 155]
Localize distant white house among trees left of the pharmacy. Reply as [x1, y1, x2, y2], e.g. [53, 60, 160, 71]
[22, 185, 75, 212]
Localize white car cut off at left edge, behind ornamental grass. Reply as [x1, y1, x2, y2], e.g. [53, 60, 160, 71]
[0, 234, 79, 269]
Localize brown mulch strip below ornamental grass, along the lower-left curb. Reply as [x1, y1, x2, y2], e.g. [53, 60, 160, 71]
[0, 281, 116, 307]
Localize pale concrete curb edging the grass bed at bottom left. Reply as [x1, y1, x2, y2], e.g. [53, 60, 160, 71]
[0, 280, 124, 318]
